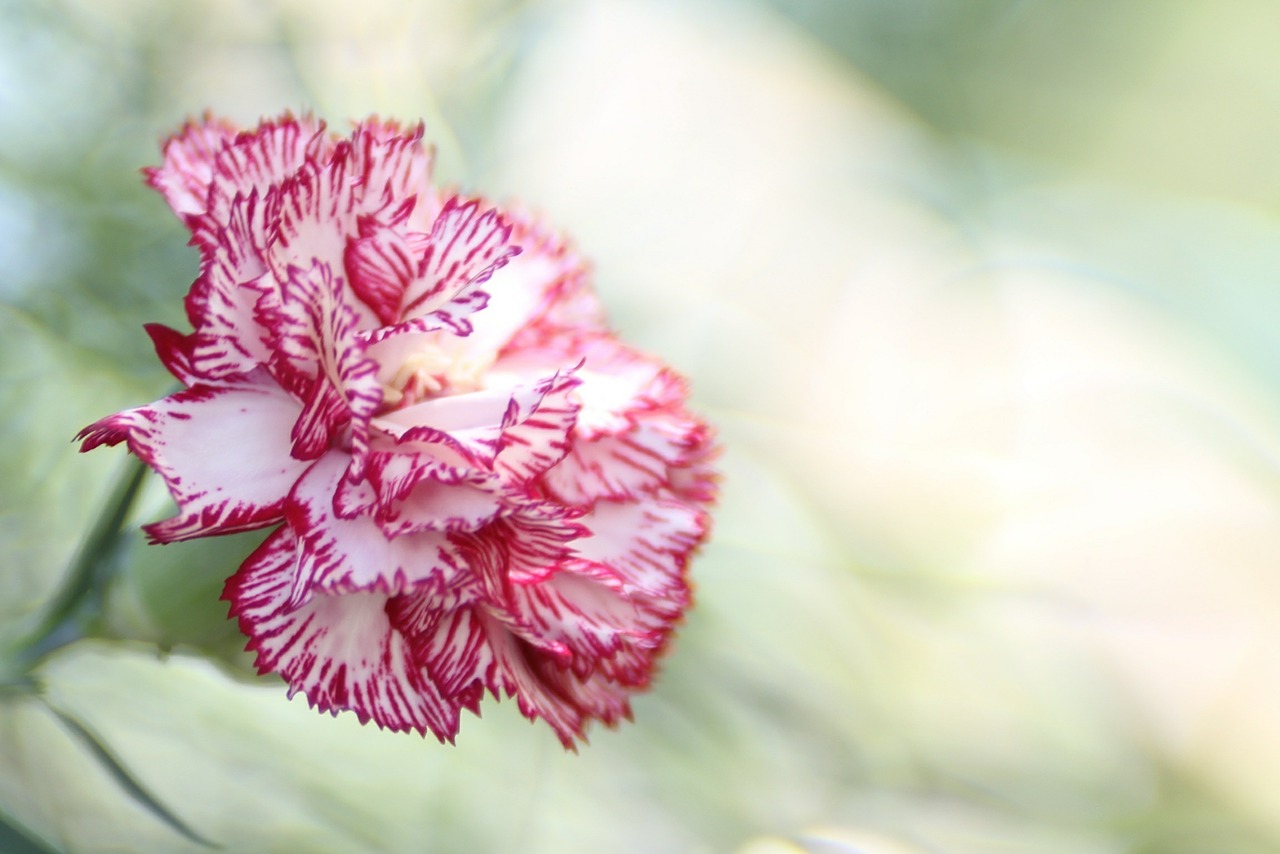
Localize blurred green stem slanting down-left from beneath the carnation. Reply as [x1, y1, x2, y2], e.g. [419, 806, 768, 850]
[5, 456, 147, 681]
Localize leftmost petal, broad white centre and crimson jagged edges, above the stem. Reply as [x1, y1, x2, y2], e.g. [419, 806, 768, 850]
[79, 374, 305, 543]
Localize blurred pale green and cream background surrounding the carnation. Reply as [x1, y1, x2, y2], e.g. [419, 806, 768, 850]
[0, 0, 1280, 854]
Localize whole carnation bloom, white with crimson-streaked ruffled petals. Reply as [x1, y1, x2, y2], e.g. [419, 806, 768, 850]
[81, 115, 716, 746]
